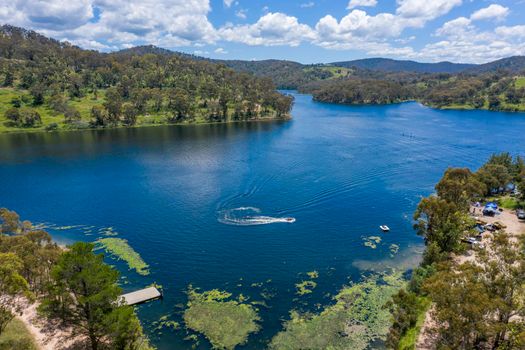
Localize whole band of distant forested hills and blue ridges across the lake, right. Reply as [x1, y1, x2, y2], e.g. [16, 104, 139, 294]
[216, 57, 525, 112]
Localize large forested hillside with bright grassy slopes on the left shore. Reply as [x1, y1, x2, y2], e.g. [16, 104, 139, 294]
[0, 26, 293, 131]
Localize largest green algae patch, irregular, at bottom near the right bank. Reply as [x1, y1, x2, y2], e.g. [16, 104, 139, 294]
[270, 273, 405, 350]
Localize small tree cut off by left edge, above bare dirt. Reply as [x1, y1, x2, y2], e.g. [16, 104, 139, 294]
[0, 253, 29, 334]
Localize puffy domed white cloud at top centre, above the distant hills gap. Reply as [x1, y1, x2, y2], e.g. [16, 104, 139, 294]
[219, 12, 314, 46]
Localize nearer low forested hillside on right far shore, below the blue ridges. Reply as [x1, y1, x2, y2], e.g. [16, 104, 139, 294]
[301, 70, 525, 112]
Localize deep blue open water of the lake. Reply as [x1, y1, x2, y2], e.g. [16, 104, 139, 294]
[0, 91, 525, 349]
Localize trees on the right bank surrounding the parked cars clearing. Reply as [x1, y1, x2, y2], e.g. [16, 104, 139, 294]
[387, 153, 525, 349]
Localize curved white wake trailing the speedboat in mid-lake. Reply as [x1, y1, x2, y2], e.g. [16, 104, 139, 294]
[218, 207, 295, 226]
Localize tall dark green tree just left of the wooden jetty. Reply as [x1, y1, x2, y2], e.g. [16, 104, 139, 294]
[41, 242, 121, 350]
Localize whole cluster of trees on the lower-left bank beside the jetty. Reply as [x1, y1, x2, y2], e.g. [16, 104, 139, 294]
[0, 208, 150, 350]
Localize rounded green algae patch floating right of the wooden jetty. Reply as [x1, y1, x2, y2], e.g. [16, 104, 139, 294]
[183, 286, 260, 349]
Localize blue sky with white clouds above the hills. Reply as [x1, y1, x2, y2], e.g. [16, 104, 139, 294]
[0, 0, 525, 63]
